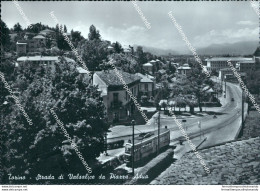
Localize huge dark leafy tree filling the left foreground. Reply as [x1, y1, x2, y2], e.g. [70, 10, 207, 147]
[3, 60, 108, 181]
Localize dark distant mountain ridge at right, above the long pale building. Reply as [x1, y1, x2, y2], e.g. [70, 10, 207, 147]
[197, 41, 258, 55]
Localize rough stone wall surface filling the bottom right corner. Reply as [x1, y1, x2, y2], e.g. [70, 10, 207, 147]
[151, 137, 260, 185]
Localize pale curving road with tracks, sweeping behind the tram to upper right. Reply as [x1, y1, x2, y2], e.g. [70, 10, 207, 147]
[101, 80, 247, 161]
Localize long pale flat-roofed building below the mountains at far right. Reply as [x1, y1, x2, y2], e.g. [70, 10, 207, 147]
[205, 57, 254, 72]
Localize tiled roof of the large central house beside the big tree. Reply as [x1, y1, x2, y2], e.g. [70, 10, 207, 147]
[95, 70, 141, 86]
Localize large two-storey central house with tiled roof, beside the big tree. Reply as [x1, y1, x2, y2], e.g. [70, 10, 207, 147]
[93, 70, 141, 122]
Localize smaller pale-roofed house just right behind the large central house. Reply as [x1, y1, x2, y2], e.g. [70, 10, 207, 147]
[135, 73, 155, 97]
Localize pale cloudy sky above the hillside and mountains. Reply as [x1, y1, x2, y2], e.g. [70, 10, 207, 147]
[1, 1, 259, 52]
